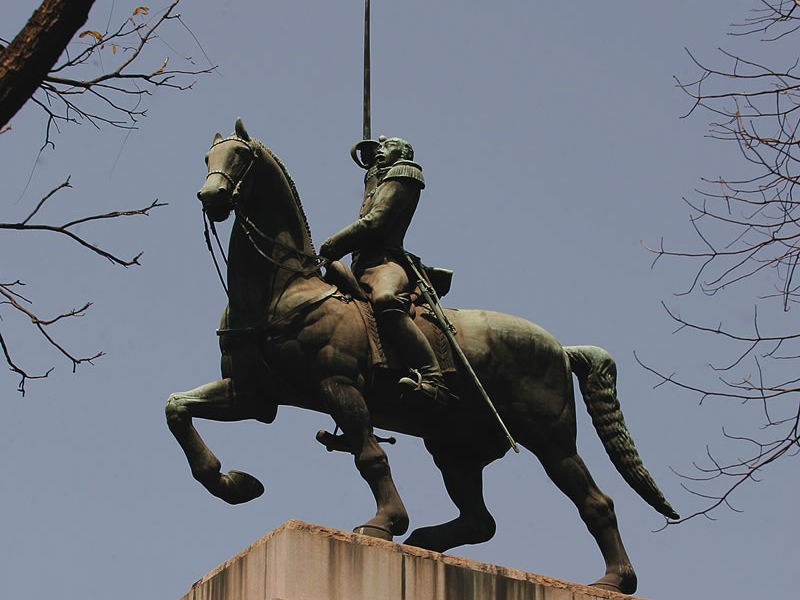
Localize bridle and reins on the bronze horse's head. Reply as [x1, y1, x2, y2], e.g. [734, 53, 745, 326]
[203, 134, 330, 295]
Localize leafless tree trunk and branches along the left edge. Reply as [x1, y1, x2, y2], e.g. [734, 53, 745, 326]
[0, 0, 215, 395]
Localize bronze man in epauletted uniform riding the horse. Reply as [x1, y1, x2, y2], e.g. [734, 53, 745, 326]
[320, 136, 455, 403]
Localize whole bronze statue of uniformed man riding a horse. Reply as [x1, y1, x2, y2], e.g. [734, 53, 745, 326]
[166, 119, 678, 594]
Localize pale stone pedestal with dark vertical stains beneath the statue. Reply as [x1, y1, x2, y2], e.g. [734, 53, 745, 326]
[181, 521, 644, 600]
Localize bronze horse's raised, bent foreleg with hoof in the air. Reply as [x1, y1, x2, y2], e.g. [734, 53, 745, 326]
[165, 379, 264, 504]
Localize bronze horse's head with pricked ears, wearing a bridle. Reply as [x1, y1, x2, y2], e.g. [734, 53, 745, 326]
[197, 118, 256, 221]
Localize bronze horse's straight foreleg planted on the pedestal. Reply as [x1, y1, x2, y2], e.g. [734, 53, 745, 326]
[320, 377, 408, 540]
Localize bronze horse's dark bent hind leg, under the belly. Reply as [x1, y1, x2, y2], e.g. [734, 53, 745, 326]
[404, 443, 502, 552]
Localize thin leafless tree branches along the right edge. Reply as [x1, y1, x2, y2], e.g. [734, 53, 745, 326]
[652, 0, 800, 521]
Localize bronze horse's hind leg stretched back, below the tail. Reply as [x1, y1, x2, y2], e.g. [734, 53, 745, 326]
[536, 438, 636, 594]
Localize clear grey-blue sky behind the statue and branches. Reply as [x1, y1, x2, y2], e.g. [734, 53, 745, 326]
[0, 0, 798, 600]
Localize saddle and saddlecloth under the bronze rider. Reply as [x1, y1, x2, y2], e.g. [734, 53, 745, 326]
[325, 260, 456, 373]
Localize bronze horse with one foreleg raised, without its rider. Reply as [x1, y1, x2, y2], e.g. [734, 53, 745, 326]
[166, 119, 678, 594]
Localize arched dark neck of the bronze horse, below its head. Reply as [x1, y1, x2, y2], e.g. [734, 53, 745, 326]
[223, 162, 325, 326]
